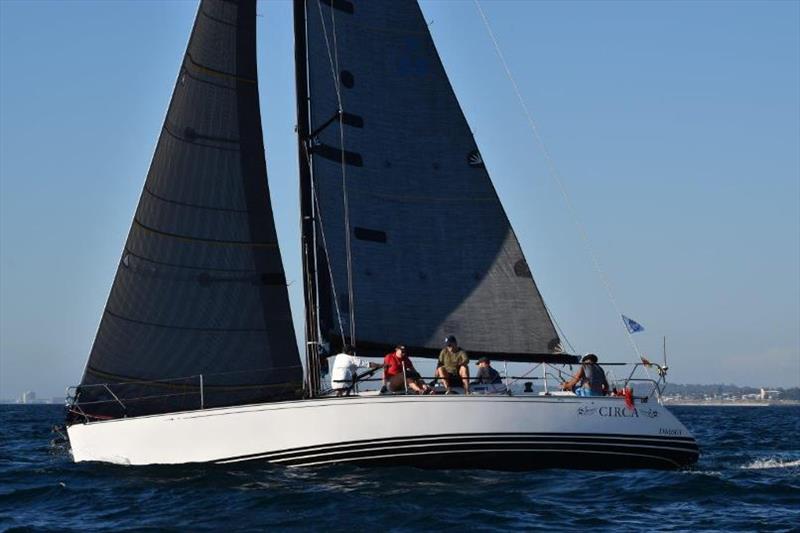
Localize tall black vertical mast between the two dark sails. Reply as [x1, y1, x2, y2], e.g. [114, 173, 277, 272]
[294, 0, 320, 397]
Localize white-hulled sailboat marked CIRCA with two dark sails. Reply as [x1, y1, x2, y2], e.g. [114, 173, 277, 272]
[67, 0, 698, 470]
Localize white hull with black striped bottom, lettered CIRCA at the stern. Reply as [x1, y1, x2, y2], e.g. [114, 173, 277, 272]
[67, 395, 698, 470]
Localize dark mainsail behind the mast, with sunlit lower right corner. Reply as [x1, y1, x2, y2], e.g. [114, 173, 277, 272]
[295, 0, 574, 362]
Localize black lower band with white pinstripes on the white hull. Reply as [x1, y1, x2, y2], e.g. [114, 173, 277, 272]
[219, 434, 699, 470]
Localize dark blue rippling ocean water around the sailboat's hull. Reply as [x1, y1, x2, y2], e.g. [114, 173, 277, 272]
[0, 405, 800, 531]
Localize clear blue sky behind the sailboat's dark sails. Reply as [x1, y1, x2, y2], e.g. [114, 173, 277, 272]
[0, 0, 800, 398]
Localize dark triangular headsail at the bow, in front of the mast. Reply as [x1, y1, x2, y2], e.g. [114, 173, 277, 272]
[74, 0, 302, 417]
